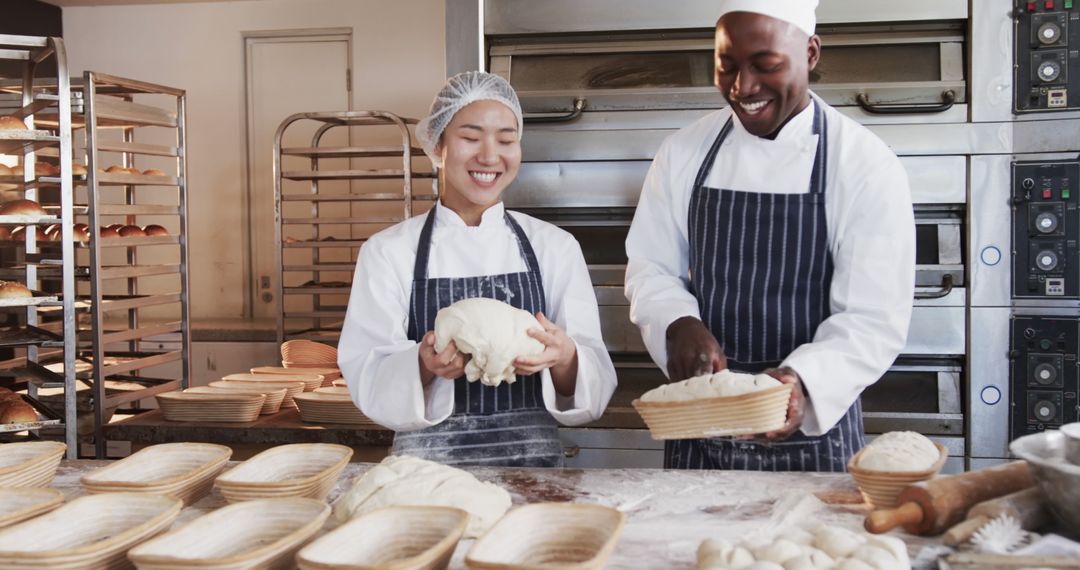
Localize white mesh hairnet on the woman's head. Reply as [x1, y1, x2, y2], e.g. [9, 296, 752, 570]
[416, 71, 524, 167]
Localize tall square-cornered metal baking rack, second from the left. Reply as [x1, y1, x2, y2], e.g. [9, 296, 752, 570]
[77, 71, 191, 457]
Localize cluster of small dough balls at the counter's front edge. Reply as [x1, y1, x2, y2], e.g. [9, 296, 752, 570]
[698, 525, 910, 570]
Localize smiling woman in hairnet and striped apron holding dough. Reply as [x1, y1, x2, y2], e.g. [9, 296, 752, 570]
[338, 72, 616, 466]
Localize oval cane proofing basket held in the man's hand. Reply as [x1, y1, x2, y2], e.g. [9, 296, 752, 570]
[633, 384, 792, 439]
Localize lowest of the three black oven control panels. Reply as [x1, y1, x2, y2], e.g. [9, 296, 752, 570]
[1010, 316, 1080, 439]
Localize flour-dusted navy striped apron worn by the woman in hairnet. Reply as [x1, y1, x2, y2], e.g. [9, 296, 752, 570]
[393, 208, 563, 467]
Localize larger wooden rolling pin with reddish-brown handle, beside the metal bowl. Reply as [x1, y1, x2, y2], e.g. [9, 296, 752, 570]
[863, 461, 1035, 535]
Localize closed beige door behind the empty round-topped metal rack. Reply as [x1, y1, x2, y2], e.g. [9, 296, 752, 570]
[244, 30, 351, 318]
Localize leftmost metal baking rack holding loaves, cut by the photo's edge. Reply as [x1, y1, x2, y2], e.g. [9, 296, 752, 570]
[0, 35, 78, 449]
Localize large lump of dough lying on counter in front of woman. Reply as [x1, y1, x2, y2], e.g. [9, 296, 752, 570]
[334, 456, 510, 538]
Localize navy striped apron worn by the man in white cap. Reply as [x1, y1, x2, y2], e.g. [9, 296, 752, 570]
[664, 101, 864, 472]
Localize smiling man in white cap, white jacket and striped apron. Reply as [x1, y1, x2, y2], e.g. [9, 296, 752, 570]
[626, 0, 915, 472]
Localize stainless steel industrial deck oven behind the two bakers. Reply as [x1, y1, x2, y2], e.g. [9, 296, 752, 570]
[447, 0, 1080, 470]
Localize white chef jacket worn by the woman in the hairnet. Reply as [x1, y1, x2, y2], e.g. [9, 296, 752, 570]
[338, 202, 616, 431]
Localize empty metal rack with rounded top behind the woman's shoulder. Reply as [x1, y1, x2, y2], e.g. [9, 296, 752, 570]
[273, 111, 437, 344]
